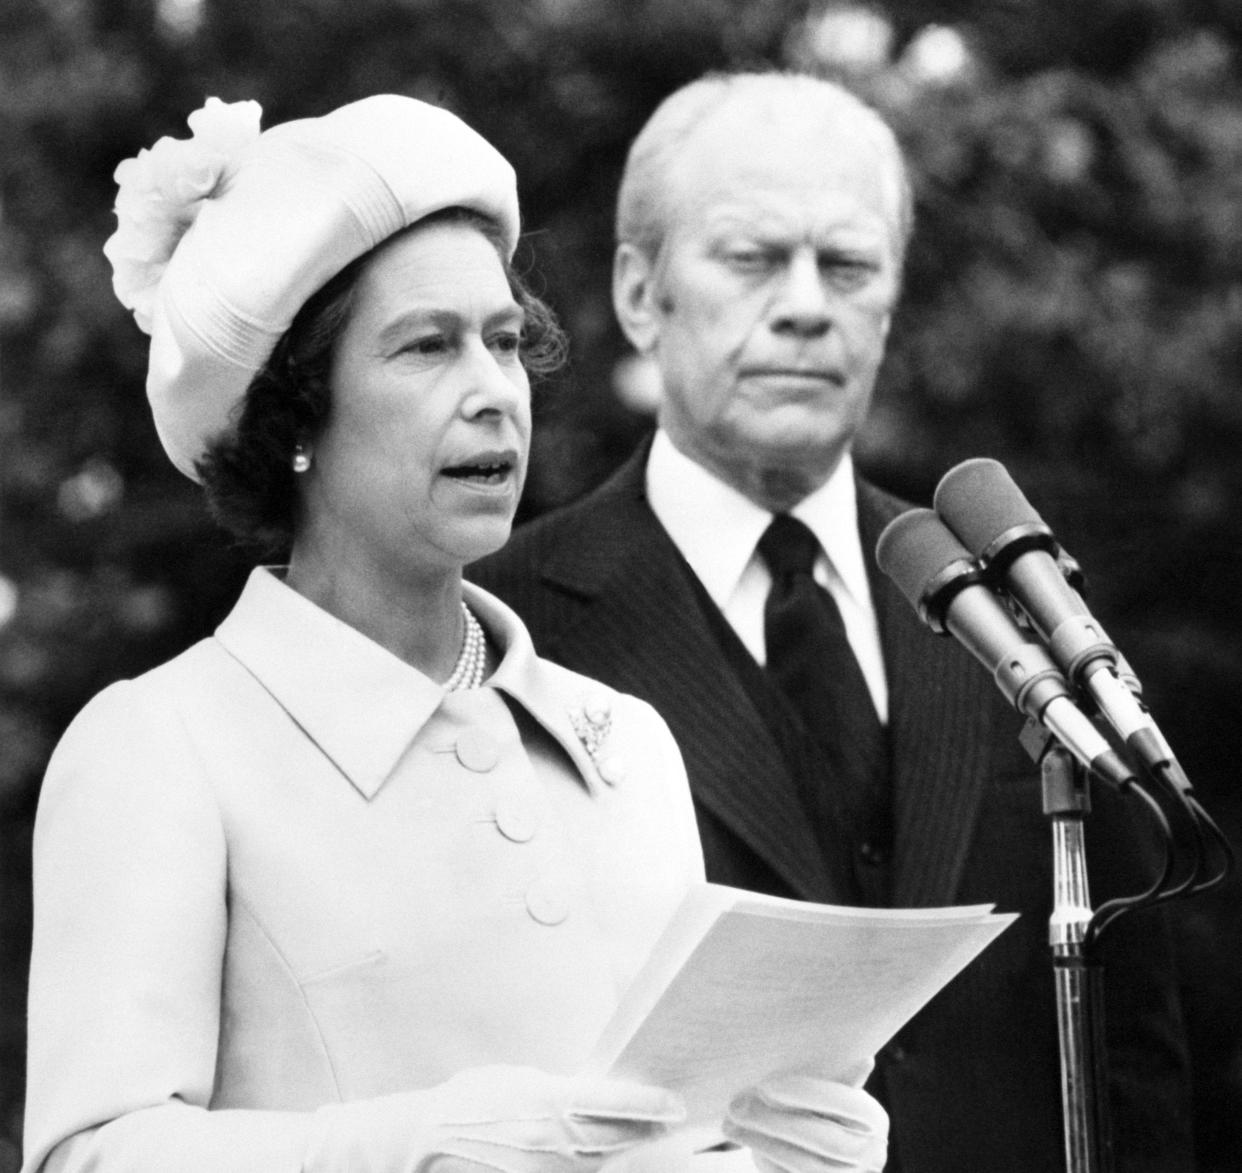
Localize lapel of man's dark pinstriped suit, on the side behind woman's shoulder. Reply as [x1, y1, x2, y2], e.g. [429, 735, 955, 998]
[542, 445, 831, 900]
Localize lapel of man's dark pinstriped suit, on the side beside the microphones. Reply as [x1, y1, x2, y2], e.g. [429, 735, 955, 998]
[858, 482, 997, 906]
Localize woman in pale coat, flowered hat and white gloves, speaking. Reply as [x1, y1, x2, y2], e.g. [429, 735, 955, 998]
[25, 96, 886, 1173]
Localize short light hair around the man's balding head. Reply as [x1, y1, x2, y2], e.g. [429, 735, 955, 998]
[616, 71, 914, 268]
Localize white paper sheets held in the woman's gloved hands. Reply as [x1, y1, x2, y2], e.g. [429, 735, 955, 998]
[589, 885, 1016, 1136]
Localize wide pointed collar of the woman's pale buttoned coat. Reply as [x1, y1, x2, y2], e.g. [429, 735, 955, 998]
[216, 567, 597, 798]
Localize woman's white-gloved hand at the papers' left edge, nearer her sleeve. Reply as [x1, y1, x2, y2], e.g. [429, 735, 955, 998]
[419, 1066, 686, 1173]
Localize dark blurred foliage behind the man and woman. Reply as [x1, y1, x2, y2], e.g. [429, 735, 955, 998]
[0, 0, 1242, 1173]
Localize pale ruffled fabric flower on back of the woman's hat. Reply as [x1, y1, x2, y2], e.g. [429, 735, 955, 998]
[103, 98, 263, 334]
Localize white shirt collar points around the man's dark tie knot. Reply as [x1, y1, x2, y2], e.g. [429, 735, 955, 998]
[647, 430, 871, 609]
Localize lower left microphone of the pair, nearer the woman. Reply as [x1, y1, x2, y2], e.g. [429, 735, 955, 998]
[876, 509, 1135, 789]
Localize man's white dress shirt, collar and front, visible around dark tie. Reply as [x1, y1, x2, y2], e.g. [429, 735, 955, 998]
[647, 430, 888, 722]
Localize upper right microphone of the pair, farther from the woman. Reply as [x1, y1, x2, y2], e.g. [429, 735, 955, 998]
[934, 457, 1190, 794]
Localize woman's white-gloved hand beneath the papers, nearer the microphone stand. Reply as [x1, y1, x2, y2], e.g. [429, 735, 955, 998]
[724, 1072, 888, 1173]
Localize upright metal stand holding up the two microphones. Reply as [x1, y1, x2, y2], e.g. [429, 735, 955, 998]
[1022, 722, 1113, 1173]
